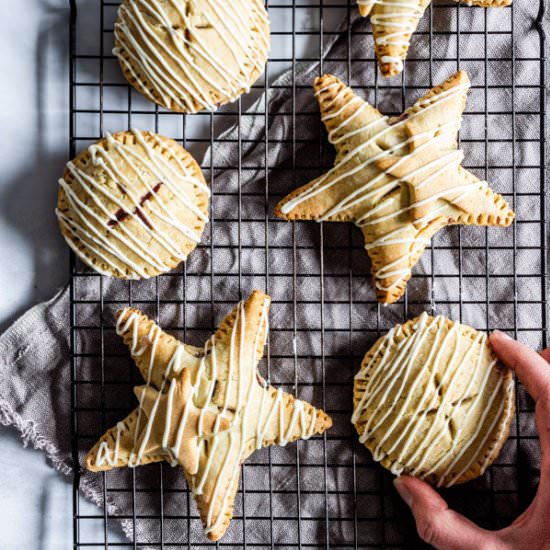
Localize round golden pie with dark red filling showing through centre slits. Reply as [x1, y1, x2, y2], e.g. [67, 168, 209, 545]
[56, 130, 210, 279]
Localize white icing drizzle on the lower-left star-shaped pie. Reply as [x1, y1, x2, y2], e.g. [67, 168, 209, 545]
[95, 298, 318, 533]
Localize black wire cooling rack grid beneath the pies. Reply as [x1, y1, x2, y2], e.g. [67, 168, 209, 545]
[70, 0, 548, 548]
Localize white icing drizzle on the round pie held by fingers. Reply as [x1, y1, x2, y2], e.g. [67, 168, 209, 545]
[352, 313, 513, 487]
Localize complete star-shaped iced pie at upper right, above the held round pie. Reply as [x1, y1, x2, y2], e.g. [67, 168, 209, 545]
[275, 72, 514, 303]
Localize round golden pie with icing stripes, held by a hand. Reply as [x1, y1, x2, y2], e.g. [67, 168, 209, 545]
[352, 313, 515, 487]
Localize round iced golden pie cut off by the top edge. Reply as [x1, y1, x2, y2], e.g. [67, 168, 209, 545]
[113, 0, 270, 113]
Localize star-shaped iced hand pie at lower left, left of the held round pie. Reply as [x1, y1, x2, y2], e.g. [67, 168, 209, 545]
[85, 291, 332, 540]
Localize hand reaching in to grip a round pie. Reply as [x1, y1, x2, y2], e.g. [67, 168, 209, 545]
[394, 332, 550, 550]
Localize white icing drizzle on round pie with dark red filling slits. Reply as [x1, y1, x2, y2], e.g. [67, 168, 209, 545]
[56, 129, 210, 279]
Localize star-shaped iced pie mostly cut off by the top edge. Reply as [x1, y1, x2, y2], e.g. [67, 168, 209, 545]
[357, 0, 512, 77]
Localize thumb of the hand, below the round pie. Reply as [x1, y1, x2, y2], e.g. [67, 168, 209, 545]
[394, 476, 498, 550]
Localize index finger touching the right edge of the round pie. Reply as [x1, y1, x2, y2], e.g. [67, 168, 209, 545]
[489, 330, 550, 401]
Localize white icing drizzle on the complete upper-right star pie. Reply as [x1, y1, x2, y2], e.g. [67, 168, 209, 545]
[281, 82, 474, 291]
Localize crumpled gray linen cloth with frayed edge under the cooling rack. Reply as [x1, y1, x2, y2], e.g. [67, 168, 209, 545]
[0, 2, 543, 547]
